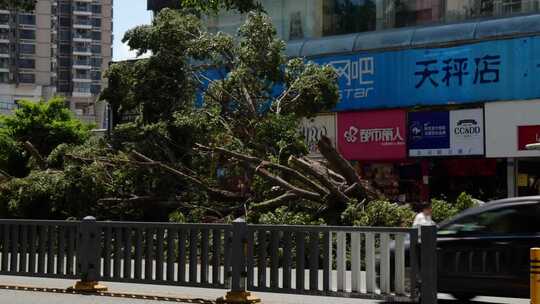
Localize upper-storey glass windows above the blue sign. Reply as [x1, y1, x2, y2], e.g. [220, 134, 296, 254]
[207, 0, 540, 41]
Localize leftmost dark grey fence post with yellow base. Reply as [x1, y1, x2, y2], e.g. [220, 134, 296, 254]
[71, 216, 107, 292]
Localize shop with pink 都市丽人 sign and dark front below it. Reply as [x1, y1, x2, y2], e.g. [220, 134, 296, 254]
[337, 110, 425, 202]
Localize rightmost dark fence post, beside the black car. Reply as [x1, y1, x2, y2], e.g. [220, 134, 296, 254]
[420, 225, 437, 304]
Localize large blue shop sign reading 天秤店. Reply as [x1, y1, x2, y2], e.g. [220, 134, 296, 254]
[311, 37, 540, 111]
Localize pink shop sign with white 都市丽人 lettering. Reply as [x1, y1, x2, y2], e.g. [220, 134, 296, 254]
[337, 110, 407, 160]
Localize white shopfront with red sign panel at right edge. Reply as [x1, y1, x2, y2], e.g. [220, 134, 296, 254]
[485, 100, 540, 196]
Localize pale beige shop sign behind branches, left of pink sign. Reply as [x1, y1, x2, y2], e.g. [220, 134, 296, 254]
[300, 113, 336, 158]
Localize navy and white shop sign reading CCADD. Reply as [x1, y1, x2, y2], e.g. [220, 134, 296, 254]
[408, 109, 484, 157]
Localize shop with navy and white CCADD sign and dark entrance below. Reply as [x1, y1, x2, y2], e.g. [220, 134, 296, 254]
[408, 108, 506, 201]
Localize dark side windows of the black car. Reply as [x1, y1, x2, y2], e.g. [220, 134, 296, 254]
[439, 204, 540, 236]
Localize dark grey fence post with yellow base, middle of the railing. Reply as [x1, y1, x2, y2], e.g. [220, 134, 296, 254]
[217, 218, 261, 304]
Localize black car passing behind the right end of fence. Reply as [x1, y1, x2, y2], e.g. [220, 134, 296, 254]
[437, 196, 540, 300]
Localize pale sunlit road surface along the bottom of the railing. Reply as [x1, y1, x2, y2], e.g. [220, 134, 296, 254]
[0, 276, 530, 304]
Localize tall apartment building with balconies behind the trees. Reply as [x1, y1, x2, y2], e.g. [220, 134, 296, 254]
[0, 0, 113, 126]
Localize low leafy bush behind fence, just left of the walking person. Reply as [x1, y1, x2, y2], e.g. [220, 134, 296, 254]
[342, 200, 415, 227]
